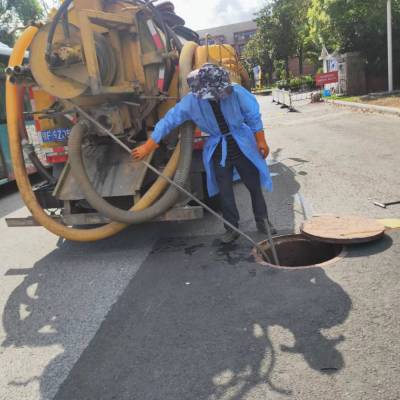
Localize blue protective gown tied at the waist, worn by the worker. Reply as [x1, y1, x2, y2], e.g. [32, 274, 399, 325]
[151, 84, 272, 196]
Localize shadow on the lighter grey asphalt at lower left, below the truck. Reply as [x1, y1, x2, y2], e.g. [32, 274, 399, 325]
[0, 227, 155, 399]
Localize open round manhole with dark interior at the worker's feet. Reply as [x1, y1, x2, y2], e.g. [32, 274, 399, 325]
[260, 235, 343, 268]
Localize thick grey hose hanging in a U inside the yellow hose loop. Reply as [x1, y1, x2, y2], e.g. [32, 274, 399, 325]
[68, 121, 194, 224]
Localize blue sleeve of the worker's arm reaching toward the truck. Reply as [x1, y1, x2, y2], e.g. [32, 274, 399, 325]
[151, 95, 191, 143]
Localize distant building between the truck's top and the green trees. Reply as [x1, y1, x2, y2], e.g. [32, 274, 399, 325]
[197, 21, 257, 55]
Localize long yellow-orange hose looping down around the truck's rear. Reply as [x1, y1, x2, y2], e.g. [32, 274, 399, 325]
[6, 26, 193, 242]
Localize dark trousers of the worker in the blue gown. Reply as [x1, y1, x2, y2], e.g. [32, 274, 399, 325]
[213, 154, 268, 228]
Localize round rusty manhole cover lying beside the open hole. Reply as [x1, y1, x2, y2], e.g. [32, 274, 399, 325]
[300, 215, 385, 244]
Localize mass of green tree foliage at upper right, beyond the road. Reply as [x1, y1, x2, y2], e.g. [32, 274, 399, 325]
[246, 0, 400, 84]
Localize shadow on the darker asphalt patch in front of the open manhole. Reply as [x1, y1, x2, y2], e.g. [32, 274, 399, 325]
[51, 237, 351, 400]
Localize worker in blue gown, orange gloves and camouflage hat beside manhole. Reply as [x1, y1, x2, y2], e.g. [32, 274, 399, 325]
[132, 63, 276, 243]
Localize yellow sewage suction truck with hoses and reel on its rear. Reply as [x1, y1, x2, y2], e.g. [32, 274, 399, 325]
[6, 0, 249, 242]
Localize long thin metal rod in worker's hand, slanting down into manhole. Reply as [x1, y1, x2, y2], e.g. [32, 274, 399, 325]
[69, 102, 280, 266]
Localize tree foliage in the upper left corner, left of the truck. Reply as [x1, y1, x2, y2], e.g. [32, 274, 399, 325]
[0, 0, 43, 46]
